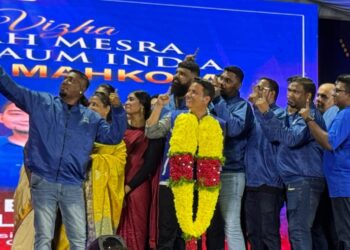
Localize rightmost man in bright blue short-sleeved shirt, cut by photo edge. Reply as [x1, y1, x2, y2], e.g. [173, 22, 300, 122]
[300, 75, 350, 250]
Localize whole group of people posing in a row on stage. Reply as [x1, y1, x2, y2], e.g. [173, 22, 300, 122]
[0, 53, 350, 250]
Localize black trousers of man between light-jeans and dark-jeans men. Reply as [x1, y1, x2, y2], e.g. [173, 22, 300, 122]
[244, 187, 284, 250]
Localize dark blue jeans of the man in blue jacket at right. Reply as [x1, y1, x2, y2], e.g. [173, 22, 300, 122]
[287, 178, 325, 250]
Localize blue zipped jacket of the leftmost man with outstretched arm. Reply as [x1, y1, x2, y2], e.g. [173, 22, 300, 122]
[0, 68, 127, 185]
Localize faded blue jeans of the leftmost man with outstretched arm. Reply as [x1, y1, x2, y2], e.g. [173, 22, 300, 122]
[30, 173, 86, 250]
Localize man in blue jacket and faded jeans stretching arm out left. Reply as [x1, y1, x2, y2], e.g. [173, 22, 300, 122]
[0, 67, 127, 250]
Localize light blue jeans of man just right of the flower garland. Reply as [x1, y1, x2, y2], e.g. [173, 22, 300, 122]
[219, 173, 245, 250]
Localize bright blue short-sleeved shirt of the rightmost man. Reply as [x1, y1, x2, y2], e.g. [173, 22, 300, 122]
[324, 107, 350, 197]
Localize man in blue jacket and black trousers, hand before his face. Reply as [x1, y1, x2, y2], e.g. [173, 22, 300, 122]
[244, 77, 286, 250]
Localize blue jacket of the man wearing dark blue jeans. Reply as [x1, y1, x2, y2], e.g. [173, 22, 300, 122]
[260, 104, 326, 184]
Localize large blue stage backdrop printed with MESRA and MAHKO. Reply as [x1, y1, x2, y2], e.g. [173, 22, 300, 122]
[0, 0, 317, 249]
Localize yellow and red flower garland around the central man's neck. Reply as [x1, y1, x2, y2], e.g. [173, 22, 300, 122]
[169, 113, 223, 249]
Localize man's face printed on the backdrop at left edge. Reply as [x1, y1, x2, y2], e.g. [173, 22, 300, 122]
[0, 103, 29, 134]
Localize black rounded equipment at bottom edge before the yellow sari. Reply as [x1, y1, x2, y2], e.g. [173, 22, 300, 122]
[87, 235, 128, 250]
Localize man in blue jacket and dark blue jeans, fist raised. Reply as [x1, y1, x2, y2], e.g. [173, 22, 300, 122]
[255, 77, 325, 250]
